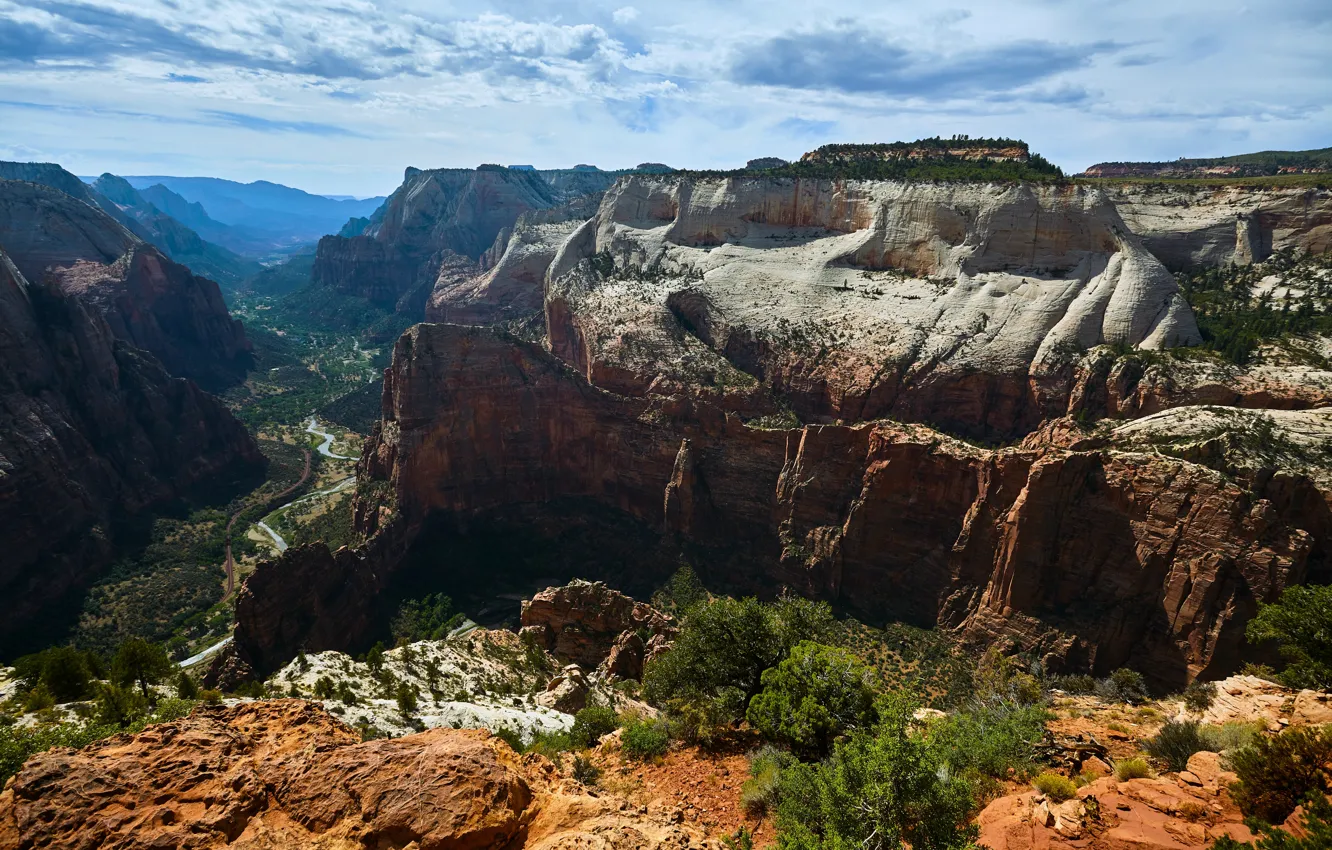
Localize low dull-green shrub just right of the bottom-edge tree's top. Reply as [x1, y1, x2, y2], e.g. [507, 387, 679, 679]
[930, 705, 1050, 779]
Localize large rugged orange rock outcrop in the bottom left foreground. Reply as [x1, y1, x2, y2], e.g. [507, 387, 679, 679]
[0, 699, 719, 850]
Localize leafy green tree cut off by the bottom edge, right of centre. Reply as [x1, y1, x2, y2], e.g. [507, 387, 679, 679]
[777, 694, 975, 850]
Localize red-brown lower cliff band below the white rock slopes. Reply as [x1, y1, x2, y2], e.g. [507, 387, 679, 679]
[237, 325, 1328, 685]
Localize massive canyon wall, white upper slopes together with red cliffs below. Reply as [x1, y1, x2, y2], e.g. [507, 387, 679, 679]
[221, 167, 1332, 687]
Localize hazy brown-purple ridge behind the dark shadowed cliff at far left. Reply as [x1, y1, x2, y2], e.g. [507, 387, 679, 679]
[0, 180, 253, 389]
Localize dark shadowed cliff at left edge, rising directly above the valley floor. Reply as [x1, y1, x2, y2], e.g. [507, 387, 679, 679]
[0, 252, 264, 657]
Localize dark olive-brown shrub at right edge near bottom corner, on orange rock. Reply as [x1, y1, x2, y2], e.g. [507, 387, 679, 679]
[1229, 727, 1332, 823]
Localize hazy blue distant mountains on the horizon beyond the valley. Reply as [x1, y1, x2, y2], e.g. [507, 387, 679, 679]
[125, 176, 384, 256]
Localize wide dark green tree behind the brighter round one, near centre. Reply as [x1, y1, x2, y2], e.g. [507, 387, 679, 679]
[643, 597, 833, 721]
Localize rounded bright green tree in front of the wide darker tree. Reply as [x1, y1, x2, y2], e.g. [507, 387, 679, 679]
[746, 641, 875, 758]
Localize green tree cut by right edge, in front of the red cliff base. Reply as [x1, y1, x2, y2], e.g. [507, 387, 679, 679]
[1247, 586, 1332, 690]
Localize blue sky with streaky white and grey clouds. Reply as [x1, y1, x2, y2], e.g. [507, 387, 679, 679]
[0, 0, 1332, 196]
